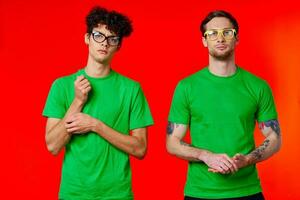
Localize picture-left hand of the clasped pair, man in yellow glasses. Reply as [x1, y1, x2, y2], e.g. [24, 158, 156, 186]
[203, 152, 238, 174]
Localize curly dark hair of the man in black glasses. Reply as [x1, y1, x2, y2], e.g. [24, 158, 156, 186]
[85, 6, 133, 43]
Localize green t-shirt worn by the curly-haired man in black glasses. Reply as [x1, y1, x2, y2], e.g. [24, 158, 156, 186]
[43, 69, 153, 200]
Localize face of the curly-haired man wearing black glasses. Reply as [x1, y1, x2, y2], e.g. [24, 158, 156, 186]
[85, 24, 120, 65]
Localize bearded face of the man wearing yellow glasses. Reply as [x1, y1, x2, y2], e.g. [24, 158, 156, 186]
[202, 17, 238, 60]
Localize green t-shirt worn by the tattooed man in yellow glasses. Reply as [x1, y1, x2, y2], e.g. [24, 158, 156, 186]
[169, 67, 277, 198]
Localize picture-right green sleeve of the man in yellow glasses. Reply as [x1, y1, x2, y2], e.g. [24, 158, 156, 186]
[256, 82, 277, 122]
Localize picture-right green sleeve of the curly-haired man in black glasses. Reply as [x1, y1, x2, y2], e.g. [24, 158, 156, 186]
[129, 84, 153, 130]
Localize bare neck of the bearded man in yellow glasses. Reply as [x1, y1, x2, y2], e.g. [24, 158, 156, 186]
[208, 55, 236, 77]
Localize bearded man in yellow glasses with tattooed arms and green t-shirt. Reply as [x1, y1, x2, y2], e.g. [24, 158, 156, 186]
[167, 11, 281, 200]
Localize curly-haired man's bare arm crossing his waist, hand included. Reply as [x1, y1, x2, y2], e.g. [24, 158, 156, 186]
[65, 113, 147, 159]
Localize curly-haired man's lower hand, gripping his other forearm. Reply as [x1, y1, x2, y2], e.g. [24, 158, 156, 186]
[65, 113, 96, 134]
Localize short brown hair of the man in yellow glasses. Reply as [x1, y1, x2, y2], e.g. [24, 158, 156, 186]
[200, 10, 239, 36]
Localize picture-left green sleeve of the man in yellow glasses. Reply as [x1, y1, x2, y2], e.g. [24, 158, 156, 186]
[168, 82, 190, 124]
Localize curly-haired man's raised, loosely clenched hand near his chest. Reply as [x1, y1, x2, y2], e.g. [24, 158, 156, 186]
[74, 75, 92, 103]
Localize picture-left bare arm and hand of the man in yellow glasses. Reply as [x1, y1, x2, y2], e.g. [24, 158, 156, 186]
[167, 122, 237, 174]
